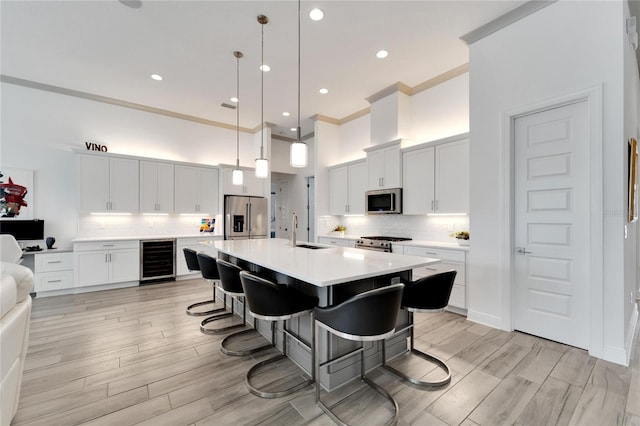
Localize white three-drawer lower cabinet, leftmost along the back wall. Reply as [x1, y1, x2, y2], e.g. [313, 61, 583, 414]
[33, 251, 73, 293]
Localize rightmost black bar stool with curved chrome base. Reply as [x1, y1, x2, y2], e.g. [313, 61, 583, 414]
[382, 270, 456, 388]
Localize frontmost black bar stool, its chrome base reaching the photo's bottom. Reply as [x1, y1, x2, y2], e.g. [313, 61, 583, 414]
[314, 284, 404, 425]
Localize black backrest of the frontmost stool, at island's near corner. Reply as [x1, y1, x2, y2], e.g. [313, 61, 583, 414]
[314, 284, 404, 336]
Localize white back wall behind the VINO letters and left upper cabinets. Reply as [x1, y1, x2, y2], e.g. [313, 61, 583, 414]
[0, 83, 280, 247]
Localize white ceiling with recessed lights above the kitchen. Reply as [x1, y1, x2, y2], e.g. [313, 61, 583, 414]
[0, 0, 524, 137]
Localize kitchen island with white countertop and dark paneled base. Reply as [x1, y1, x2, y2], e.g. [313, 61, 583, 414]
[206, 238, 439, 389]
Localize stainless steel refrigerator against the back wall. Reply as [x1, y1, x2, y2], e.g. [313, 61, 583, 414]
[224, 195, 269, 240]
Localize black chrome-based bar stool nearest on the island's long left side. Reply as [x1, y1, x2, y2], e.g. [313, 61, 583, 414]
[240, 271, 318, 398]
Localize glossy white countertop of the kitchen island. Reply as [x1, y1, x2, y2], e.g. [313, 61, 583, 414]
[208, 238, 440, 287]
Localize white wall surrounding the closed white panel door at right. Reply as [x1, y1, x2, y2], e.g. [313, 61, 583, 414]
[468, 1, 637, 362]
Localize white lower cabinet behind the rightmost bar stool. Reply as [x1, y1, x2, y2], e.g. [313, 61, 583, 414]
[404, 246, 467, 309]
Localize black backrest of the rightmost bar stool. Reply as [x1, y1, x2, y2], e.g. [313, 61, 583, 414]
[402, 269, 457, 310]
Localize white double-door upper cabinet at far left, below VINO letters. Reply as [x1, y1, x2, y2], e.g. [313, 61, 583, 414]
[77, 154, 139, 213]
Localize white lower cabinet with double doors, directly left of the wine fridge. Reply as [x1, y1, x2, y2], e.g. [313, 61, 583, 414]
[73, 240, 140, 287]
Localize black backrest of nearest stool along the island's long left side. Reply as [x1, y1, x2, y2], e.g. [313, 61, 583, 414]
[240, 271, 318, 317]
